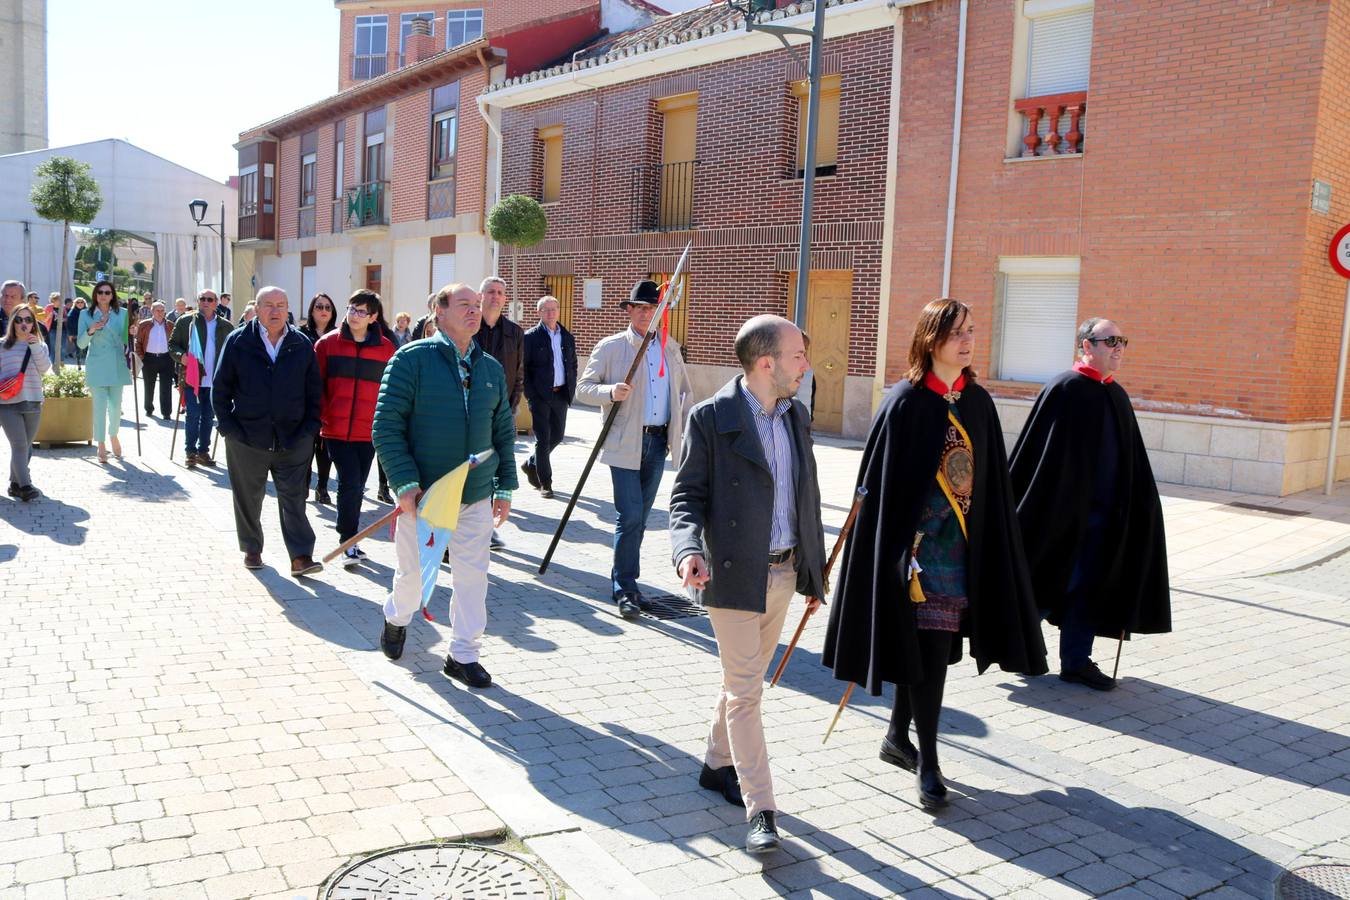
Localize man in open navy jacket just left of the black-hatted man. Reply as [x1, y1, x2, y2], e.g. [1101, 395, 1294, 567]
[520, 297, 576, 498]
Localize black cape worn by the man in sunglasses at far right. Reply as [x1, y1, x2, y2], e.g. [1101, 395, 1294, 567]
[1013, 370, 1172, 637]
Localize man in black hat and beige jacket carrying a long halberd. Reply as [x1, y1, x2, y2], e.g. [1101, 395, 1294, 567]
[576, 279, 694, 618]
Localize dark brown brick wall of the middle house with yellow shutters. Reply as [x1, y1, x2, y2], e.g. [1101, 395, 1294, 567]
[502, 28, 892, 376]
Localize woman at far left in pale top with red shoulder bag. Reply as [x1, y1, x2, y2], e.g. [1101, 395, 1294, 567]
[0, 306, 51, 503]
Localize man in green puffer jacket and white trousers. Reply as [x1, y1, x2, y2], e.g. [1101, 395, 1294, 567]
[371, 283, 516, 688]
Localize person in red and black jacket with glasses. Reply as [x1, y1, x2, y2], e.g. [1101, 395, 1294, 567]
[315, 290, 394, 568]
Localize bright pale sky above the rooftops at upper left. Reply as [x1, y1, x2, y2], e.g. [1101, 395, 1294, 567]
[47, 0, 705, 181]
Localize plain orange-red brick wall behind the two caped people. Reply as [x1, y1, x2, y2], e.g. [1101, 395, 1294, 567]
[886, 0, 1328, 421]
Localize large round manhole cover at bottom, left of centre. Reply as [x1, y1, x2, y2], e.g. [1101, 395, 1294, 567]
[323, 843, 556, 900]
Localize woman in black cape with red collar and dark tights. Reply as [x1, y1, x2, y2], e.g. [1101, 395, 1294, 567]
[822, 300, 1046, 810]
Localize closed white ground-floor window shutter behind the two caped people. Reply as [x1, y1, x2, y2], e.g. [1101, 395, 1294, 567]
[999, 267, 1079, 382]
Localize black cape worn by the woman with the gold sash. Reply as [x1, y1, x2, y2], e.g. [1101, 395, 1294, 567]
[821, 381, 1046, 696]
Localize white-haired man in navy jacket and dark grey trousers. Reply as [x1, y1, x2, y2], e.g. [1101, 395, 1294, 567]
[211, 287, 323, 578]
